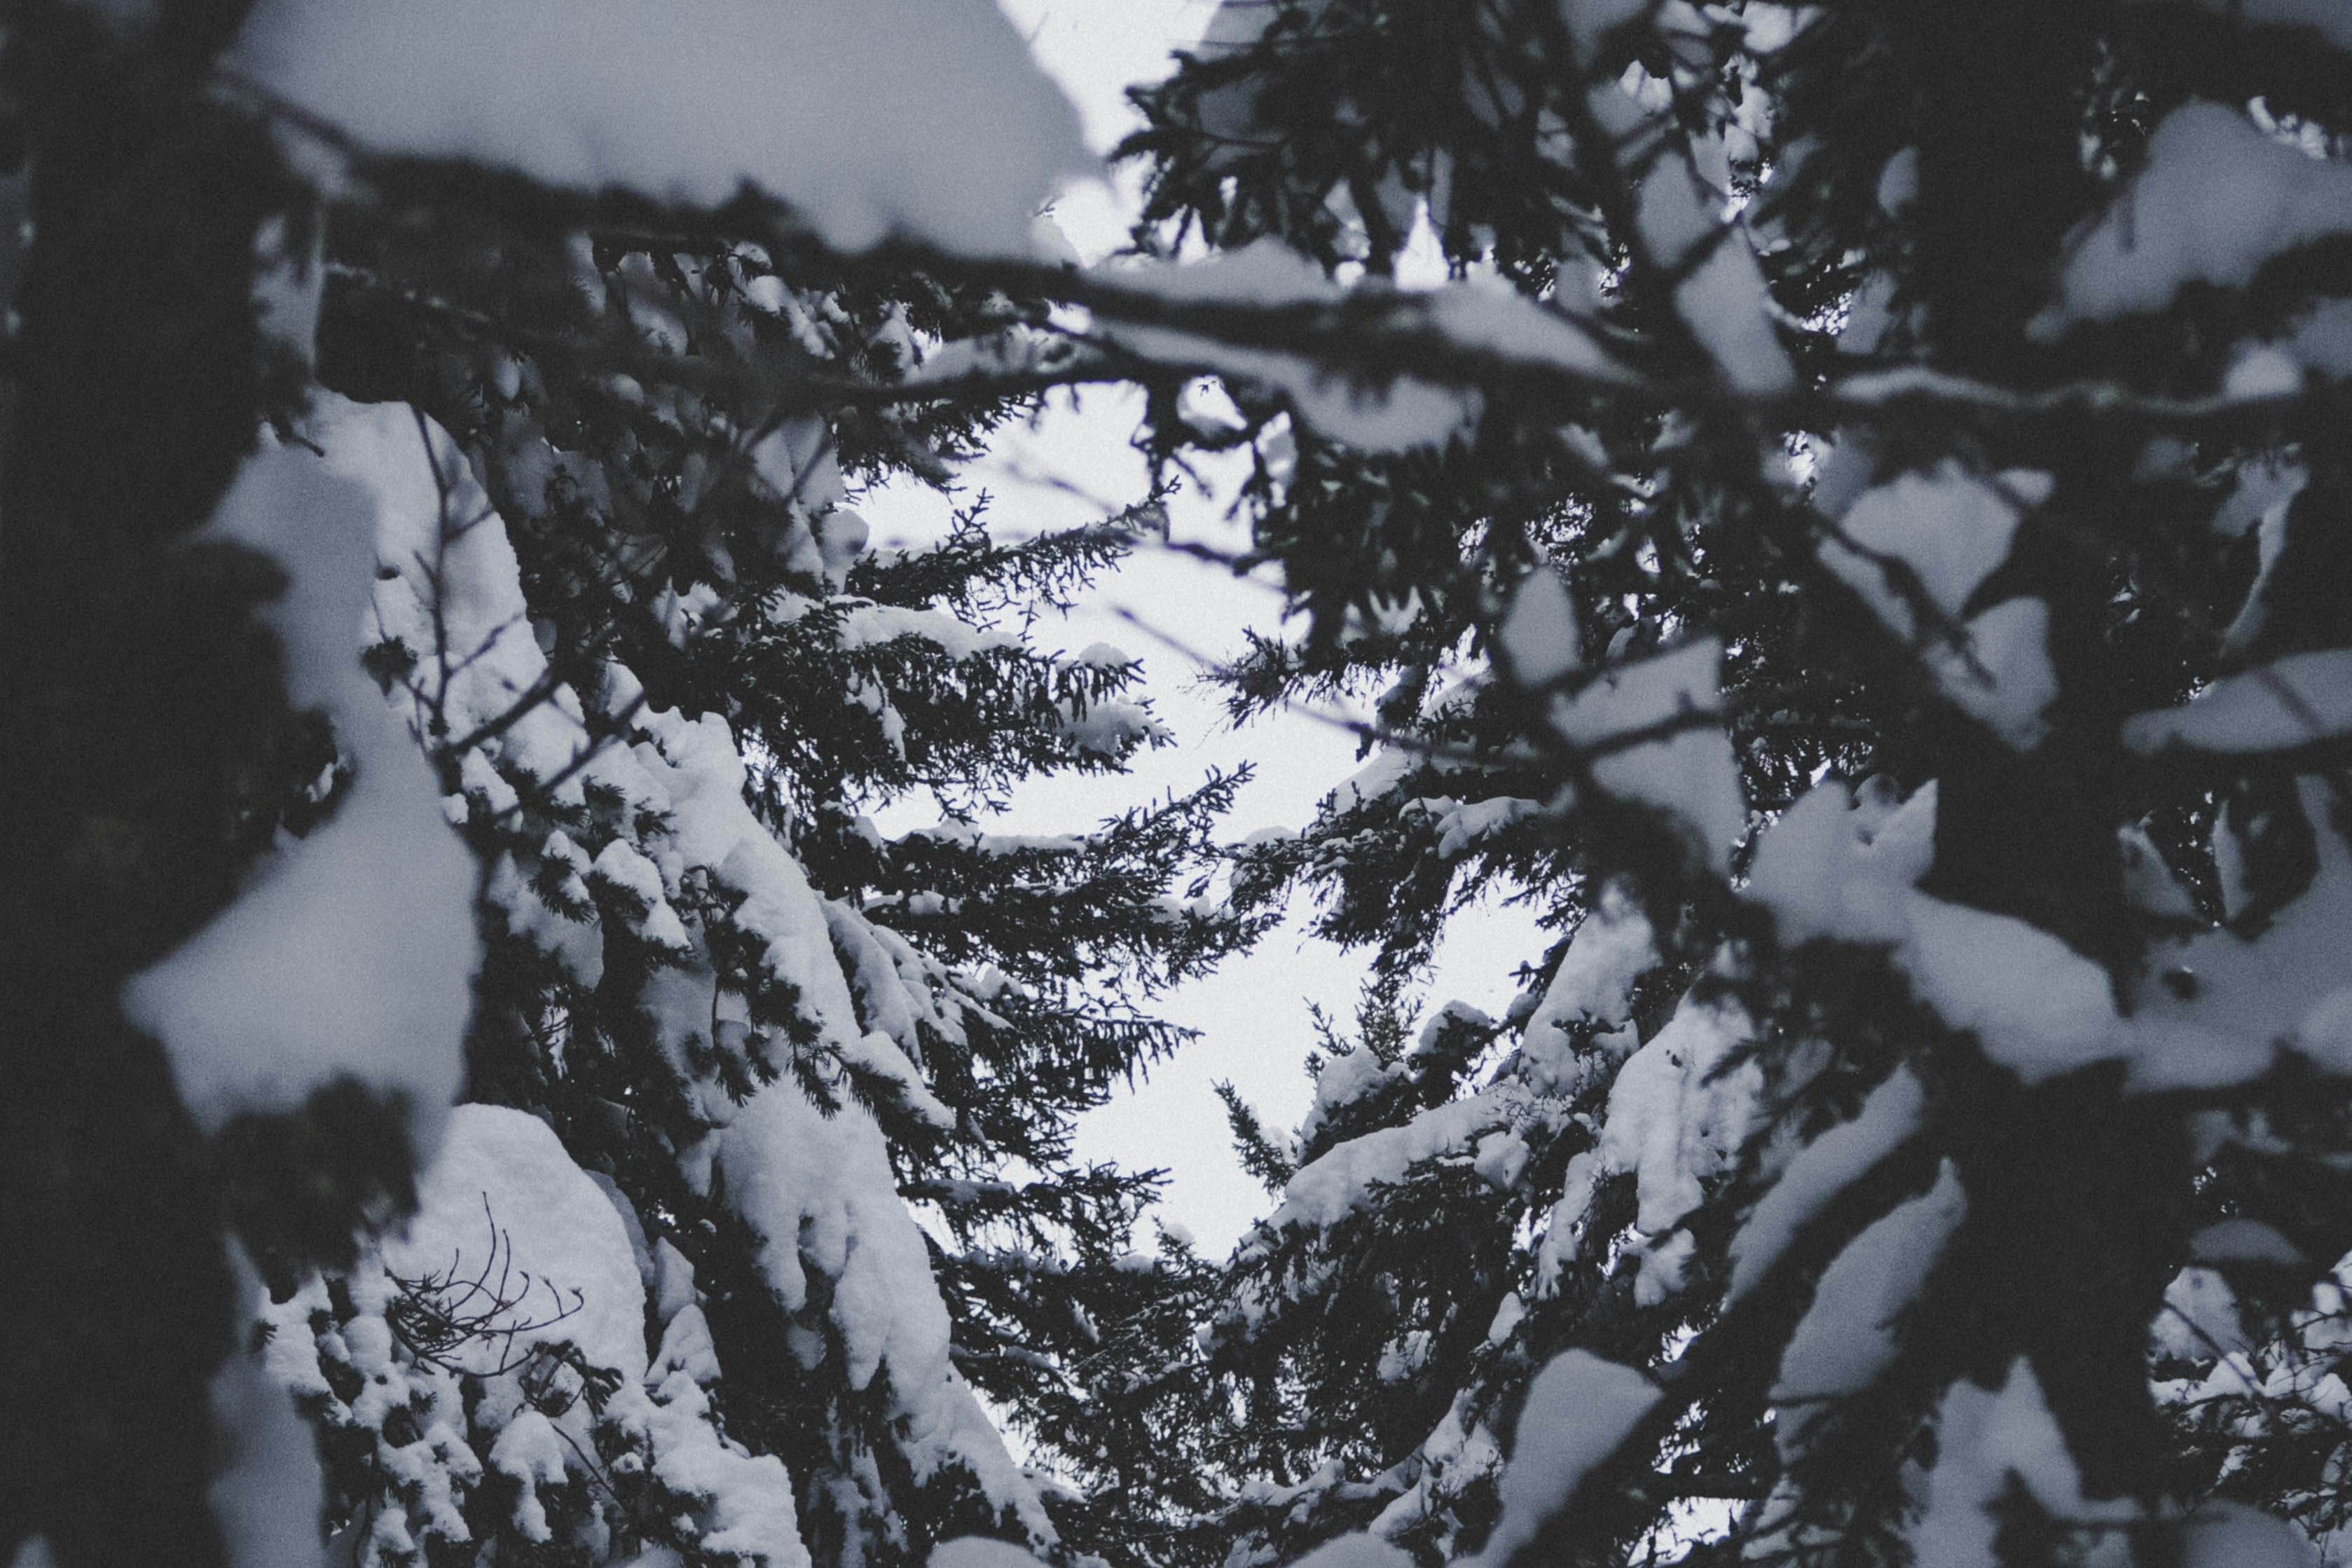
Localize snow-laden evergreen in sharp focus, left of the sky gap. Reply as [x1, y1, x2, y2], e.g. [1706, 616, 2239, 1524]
[273, 128, 1288, 1561]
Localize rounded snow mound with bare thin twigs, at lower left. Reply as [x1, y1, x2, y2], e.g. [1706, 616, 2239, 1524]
[256, 1105, 809, 1568]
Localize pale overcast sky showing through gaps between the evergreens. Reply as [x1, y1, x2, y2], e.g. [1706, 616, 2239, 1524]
[858, 0, 1543, 1256]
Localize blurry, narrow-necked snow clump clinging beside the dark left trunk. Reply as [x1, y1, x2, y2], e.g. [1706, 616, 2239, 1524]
[123, 432, 480, 1145]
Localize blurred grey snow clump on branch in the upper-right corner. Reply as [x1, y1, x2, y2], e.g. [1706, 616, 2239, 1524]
[2035, 101, 2352, 336]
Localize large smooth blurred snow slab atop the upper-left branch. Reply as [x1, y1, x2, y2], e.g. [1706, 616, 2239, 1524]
[228, 0, 1092, 256]
